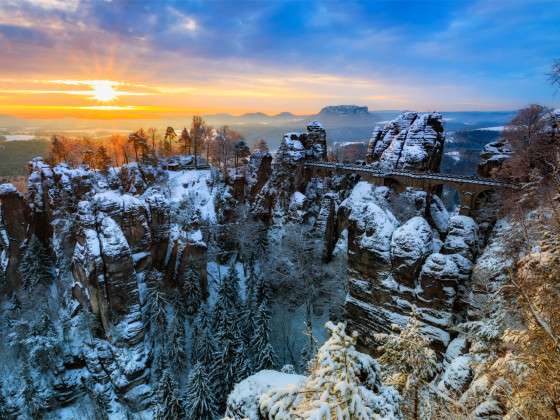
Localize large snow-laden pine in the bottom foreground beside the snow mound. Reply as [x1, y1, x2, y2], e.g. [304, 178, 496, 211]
[260, 322, 401, 420]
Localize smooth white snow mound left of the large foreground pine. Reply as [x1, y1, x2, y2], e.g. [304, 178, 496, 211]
[226, 370, 306, 420]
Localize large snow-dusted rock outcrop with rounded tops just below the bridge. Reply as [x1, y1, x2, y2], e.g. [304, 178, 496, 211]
[341, 182, 478, 352]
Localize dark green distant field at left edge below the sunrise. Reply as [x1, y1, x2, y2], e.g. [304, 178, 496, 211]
[0, 140, 49, 177]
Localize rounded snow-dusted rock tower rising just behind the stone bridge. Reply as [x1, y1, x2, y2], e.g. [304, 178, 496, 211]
[366, 112, 445, 172]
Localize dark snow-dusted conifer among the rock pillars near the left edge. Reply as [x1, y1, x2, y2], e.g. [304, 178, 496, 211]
[19, 235, 52, 290]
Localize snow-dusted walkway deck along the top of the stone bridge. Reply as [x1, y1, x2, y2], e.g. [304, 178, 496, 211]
[304, 162, 516, 188]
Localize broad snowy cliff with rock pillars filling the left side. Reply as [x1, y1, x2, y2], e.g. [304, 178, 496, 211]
[0, 159, 220, 411]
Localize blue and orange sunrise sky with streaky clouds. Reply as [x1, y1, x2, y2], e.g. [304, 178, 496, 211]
[0, 0, 560, 119]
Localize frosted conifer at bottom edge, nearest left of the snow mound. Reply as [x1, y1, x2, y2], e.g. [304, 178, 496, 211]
[185, 362, 218, 420]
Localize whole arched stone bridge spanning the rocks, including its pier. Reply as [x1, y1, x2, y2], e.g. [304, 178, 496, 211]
[304, 162, 516, 215]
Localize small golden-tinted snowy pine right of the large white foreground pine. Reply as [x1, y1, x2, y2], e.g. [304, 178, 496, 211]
[375, 318, 437, 419]
